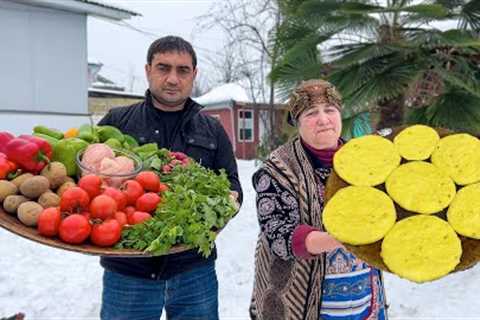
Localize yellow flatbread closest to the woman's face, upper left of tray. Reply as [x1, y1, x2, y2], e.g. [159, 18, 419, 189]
[333, 135, 401, 186]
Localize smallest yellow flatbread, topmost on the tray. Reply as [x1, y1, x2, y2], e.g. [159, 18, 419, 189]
[393, 125, 440, 160]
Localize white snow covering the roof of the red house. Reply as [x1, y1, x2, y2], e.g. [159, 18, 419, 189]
[193, 83, 250, 106]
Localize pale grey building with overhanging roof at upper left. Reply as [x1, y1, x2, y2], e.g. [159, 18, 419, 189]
[0, 0, 139, 132]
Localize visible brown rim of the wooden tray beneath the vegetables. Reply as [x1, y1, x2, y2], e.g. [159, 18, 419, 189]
[0, 207, 191, 257]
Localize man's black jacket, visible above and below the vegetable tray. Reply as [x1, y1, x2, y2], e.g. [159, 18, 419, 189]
[99, 91, 242, 279]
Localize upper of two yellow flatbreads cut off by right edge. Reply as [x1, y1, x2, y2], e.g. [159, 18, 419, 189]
[432, 133, 480, 186]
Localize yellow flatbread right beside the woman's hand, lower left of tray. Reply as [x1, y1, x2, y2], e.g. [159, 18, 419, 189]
[322, 186, 397, 245]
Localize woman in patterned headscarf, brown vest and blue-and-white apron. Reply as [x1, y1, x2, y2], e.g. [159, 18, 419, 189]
[250, 80, 386, 320]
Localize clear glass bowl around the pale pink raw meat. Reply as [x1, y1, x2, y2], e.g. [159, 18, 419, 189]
[75, 148, 143, 188]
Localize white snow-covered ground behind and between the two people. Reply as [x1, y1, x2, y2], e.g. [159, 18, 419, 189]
[0, 161, 480, 320]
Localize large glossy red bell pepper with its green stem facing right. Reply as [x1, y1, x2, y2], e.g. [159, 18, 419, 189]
[5, 138, 52, 174]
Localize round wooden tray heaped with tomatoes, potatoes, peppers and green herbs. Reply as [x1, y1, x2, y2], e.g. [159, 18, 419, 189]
[0, 126, 237, 257]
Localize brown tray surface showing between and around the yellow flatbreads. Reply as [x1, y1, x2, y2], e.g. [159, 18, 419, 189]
[325, 126, 480, 272]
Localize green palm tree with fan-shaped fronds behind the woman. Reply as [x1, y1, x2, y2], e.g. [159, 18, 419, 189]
[271, 0, 480, 133]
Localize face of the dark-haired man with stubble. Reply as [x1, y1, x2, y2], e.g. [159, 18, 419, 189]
[145, 51, 197, 107]
